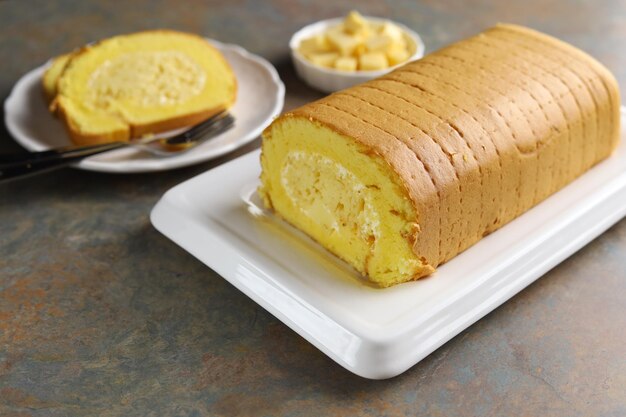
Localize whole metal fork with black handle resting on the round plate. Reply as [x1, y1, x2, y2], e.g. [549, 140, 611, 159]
[0, 112, 235, 182]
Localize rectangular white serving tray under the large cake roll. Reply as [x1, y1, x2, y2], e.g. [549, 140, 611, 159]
[151, 109, 626, 379]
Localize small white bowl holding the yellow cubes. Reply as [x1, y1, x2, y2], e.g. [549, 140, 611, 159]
[289, 16, 424, 93]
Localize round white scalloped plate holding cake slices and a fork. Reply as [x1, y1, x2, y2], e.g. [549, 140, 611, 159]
[4, 39, 285, 173]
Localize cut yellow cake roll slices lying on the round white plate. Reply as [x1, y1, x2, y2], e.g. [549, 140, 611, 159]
[49, 30, 237, 144]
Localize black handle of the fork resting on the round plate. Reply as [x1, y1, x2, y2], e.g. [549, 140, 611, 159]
[0, 142, 126, 182]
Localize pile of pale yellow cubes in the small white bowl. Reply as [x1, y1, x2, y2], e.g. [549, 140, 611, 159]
[298, 11, 415, 71]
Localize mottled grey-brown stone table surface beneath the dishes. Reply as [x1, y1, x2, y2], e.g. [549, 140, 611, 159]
[0, 0, 626, 417]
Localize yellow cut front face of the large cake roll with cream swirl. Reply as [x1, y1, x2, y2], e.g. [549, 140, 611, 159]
[259, 115, 434, 287]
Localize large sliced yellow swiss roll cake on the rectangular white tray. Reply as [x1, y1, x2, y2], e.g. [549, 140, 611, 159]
[259, 24, 620, 287]
